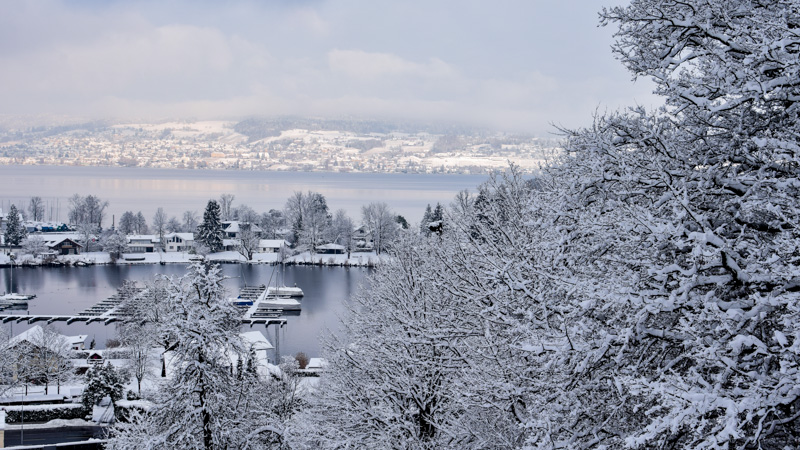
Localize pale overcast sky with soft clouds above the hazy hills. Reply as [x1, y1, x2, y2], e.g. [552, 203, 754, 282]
[0, 0, 657, 134]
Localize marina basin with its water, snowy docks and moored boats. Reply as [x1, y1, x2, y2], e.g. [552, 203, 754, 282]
[0, 264, 371, 357]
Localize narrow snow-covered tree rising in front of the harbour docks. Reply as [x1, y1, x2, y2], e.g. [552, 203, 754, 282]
[109, 263, 281, 449]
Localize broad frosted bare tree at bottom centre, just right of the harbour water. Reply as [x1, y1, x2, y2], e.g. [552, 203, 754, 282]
[291, 234, 471, 448]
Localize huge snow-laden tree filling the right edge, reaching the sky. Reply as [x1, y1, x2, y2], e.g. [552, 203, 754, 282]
[520, 0, 800, 448]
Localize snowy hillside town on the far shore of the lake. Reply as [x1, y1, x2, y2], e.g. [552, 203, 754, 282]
[0, 119, 561, 174]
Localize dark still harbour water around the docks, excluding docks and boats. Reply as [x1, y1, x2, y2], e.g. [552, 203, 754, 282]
[0, 264, 369, 356]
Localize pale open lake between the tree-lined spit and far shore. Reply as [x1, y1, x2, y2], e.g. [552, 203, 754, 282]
[0, 166, 487, 226]
